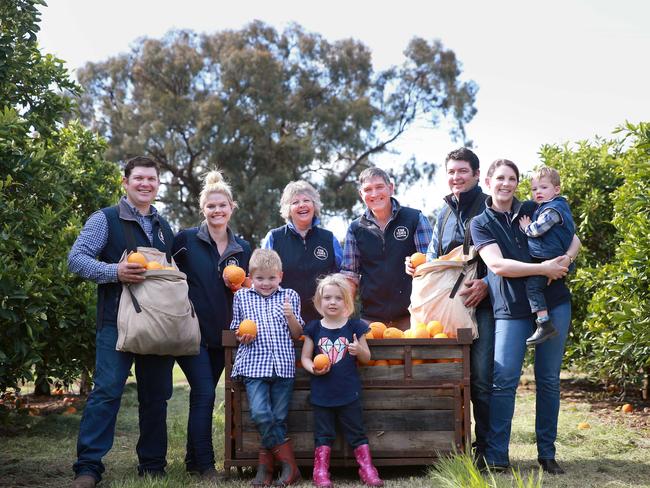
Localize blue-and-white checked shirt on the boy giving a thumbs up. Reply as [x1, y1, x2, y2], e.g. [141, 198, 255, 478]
[230, 287, 304, 378]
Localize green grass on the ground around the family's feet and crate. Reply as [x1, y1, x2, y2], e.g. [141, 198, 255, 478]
[0, 368, 650, 488]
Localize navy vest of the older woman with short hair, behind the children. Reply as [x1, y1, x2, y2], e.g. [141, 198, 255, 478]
[271, 225, 338, 323]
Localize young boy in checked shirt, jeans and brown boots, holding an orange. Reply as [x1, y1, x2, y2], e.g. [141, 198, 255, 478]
[230, 249, 304, 486]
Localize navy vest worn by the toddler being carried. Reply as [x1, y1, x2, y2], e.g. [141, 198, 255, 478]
[528, 196, 576, 259]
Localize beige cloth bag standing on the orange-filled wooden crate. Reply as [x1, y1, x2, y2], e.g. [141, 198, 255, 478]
[409, 245, 478, 339]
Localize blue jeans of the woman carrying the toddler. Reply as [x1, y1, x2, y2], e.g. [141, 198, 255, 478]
[485, 302, 571, 466]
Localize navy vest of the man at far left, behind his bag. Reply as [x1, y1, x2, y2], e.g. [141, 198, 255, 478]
[97, 206, 174, 328]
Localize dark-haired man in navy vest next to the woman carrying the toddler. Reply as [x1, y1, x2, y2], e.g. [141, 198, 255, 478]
[406, 147, 494, 459]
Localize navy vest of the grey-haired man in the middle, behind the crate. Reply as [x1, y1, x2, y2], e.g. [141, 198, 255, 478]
[350, 207, 420, 322]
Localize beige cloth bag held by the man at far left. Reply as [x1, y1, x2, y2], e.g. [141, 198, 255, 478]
[115, 247, 201, 356]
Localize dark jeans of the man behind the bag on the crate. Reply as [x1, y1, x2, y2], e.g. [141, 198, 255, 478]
[470, 307, 494, 453]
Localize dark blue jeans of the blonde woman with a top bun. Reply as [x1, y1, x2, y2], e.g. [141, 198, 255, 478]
[176, 345, 224, 473]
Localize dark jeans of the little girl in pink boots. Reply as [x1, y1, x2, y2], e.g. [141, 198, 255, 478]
[312, 400, 368, 449]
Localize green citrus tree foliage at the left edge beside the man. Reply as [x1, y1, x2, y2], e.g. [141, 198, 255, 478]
[0, 0, 119, 390]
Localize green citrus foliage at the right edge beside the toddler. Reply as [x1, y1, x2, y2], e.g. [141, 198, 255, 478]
[542, 123, 650, 386]
